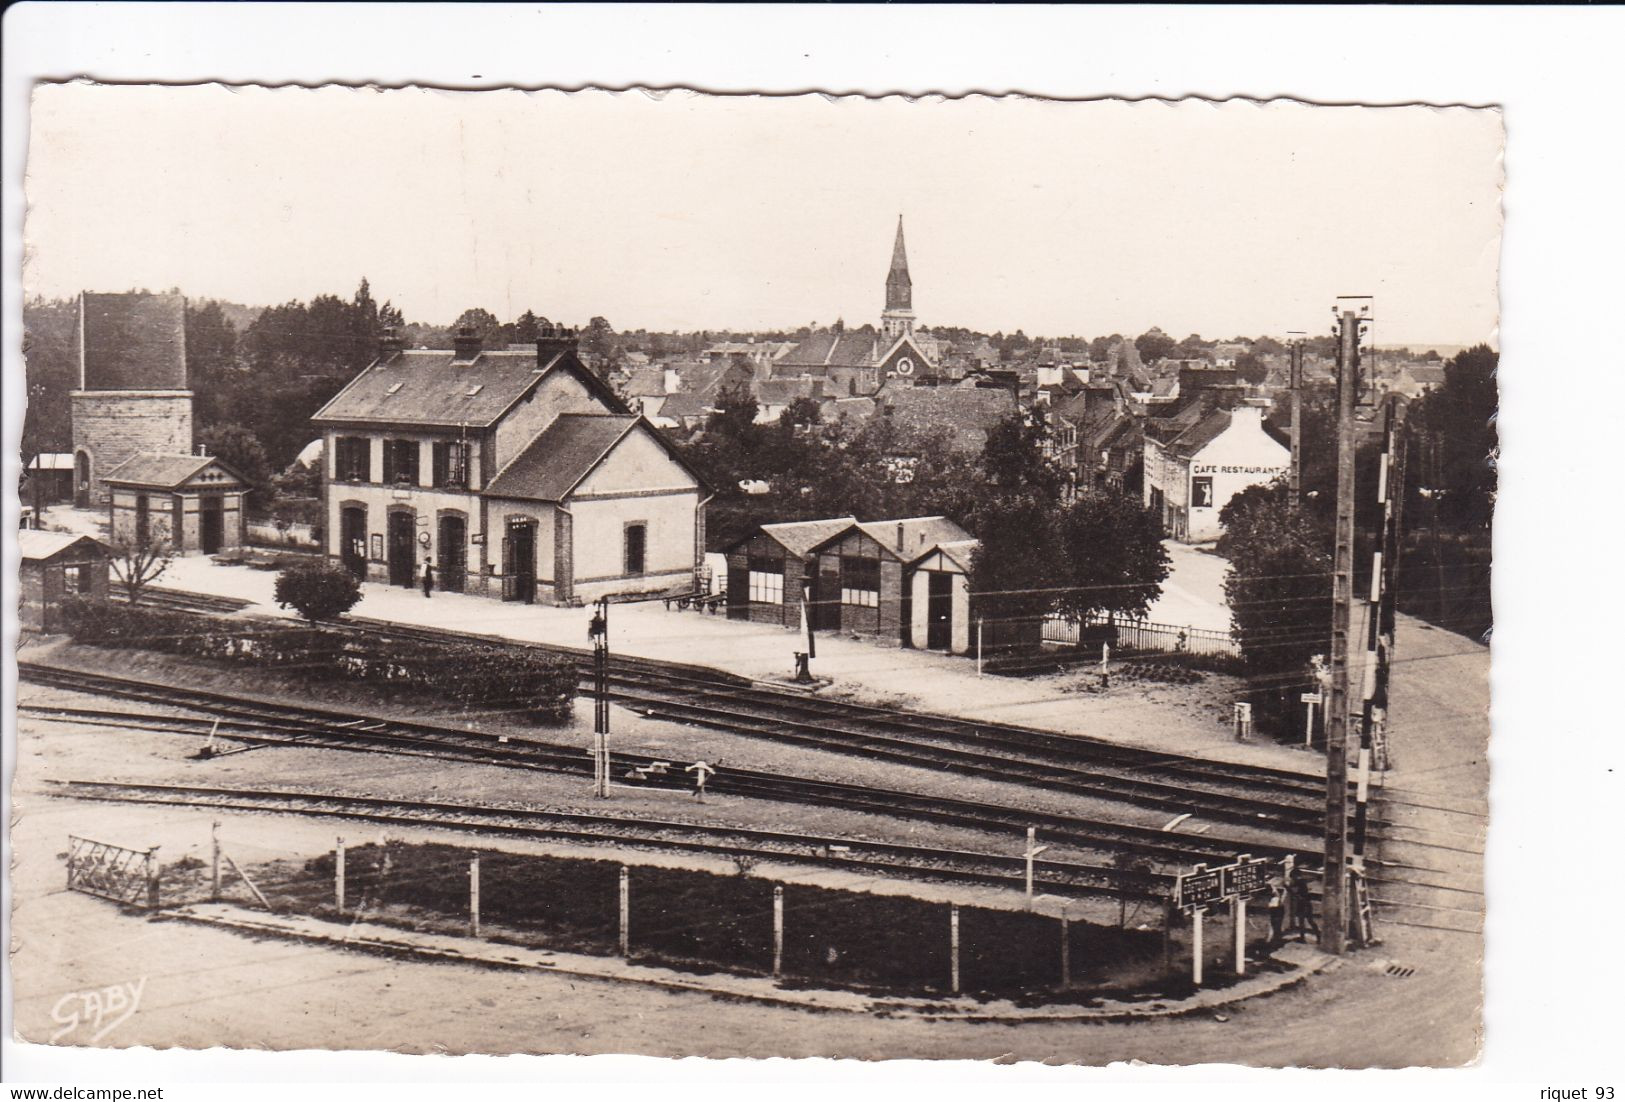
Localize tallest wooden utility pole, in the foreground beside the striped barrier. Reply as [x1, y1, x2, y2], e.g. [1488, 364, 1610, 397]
[1320, 309, 1360, 954]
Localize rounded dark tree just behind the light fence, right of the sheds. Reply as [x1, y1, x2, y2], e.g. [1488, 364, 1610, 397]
[1056, 492, 1170, 619]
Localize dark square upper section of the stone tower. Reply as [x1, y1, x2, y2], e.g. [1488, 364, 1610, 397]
[75, 293, 187, 390]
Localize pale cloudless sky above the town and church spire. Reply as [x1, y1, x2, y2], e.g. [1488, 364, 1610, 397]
[24, 83, 1503, 345]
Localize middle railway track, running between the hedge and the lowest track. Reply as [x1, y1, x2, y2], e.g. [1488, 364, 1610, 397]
[20, 663, 1488, 916]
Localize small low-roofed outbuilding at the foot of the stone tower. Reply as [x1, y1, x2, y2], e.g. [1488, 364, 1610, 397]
[104, 452, 250, 554]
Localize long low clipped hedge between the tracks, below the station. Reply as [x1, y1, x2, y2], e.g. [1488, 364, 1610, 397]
[62, 598, 579, 723]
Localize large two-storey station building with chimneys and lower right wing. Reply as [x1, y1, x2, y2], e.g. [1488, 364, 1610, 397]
[312, 323, 710, 605]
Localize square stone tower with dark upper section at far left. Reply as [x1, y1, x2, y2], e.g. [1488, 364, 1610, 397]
[70, 293, 192, 505]
